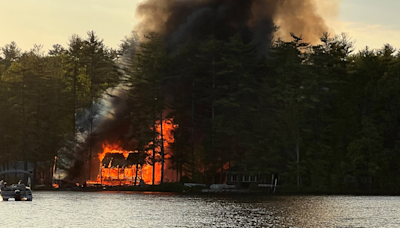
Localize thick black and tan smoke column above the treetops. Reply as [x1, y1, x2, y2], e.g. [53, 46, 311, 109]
[135, 0, 337, 51]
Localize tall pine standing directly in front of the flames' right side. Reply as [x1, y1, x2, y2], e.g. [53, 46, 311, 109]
[128, 33, 167, 185]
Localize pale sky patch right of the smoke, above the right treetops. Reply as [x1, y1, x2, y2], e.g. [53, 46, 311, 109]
[321, 0, 400, 50]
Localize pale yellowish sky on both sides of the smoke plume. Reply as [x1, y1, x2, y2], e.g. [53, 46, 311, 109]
[0, 0, 400, 51]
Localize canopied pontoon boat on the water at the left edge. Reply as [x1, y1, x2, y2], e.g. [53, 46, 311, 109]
[0, 170, 33, 201]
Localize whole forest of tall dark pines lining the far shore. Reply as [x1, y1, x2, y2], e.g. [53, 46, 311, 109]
[0, 31, 400, 194]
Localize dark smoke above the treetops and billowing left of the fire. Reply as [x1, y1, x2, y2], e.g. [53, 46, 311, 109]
[69, 0, 329, 181]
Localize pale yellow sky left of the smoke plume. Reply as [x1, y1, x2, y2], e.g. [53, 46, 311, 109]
[0, 0, 143, 50]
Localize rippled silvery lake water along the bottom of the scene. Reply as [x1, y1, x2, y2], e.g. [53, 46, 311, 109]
[0, 191, 400, 228]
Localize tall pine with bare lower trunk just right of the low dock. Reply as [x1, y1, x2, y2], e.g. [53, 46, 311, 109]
[269, 34, 309, 186]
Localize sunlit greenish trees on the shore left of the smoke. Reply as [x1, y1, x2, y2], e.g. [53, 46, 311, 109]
[0, 32, 119, 180]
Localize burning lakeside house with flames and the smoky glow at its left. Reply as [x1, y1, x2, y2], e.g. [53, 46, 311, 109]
[70, 115, 175, 186]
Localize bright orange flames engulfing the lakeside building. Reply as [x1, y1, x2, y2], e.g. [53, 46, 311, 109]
[86, 120, 176, 186]
